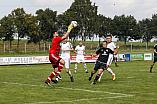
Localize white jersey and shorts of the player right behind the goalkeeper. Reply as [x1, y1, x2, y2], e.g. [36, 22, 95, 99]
[61, 42, 73, 59]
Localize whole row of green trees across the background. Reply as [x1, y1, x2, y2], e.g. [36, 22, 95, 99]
[0, 0, 157, 49]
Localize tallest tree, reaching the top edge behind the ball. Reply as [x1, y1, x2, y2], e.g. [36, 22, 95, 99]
[67, 0, 97, 45]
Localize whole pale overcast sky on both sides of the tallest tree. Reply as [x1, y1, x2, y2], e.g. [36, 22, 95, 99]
[0, 0, 157, 21]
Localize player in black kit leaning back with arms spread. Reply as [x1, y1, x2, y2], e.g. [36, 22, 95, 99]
[89, 41, 119, 84]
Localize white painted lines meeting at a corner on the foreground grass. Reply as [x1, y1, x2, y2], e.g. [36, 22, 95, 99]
[1, 82, 134, 104]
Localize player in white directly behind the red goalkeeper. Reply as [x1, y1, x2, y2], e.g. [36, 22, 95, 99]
[61, 39, 74, 82]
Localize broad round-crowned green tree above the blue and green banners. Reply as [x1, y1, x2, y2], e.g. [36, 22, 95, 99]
[113, 15, 140, 46]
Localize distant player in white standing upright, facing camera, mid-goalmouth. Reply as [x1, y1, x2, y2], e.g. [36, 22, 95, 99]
[74, 41, 88, 74]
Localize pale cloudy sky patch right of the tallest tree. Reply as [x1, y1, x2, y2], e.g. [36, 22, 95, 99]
[92, 0, 157, 20]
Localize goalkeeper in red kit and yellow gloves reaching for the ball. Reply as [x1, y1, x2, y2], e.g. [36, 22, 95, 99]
[45, 24, 73, 87]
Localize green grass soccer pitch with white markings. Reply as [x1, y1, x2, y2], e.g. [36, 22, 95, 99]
[0, 61, 157, 104]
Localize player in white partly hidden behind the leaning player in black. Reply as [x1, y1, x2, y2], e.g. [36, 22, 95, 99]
[98, 35, 120, 82]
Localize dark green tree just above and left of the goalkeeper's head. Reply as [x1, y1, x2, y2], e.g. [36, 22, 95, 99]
[36, 8, 58, 49]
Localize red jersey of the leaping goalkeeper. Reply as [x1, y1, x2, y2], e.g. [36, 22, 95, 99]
[49, 37, 62, 56]
